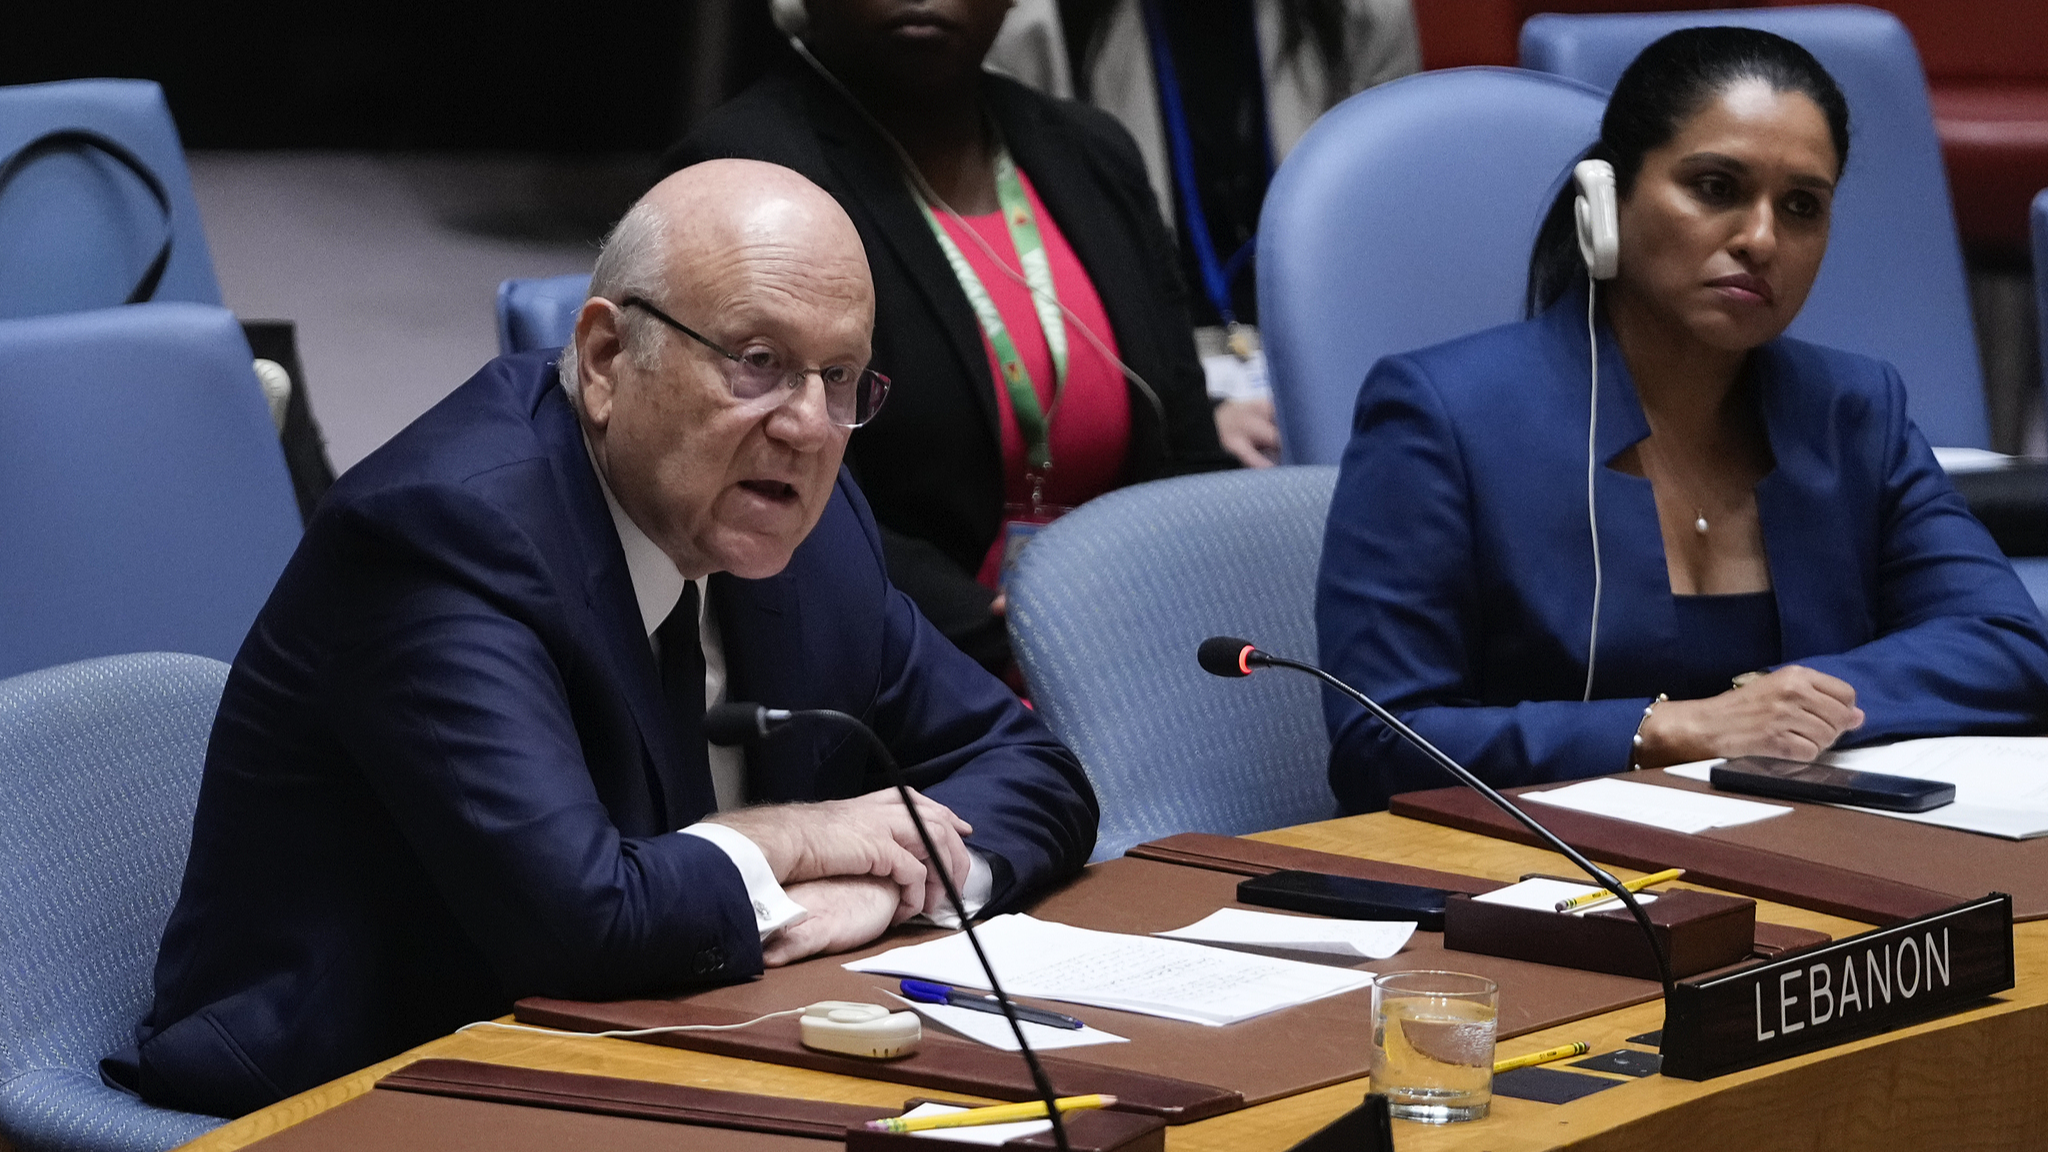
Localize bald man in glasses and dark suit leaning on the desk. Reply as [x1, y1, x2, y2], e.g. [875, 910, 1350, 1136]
[104, 160, 1096, 1115]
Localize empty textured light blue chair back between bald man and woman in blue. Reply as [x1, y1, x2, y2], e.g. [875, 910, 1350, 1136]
[1010, 467, 1337, 859]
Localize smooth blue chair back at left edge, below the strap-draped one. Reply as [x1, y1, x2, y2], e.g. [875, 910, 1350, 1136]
[0, 303, 299, 676]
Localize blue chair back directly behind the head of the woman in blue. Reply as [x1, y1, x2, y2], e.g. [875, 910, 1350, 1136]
[1522, 6, 1991, 449]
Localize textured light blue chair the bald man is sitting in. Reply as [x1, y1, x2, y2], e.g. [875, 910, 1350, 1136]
[0, 652, 227, 1152]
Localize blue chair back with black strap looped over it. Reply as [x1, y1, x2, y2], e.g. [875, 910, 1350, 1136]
[0, 80, 221, 318]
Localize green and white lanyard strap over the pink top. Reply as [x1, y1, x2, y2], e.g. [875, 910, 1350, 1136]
[918, 146, 1067, 478]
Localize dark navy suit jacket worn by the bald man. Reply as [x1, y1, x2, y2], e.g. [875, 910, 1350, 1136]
[109, 353, 1096, 1115]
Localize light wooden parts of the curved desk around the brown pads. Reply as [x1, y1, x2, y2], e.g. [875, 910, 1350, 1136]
[186, 812, 2048, 1152]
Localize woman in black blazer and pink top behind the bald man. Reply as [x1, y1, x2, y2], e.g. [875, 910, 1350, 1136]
[668, 0, 1231, 670]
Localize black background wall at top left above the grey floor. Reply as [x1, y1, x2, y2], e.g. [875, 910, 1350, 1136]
[0, 0, 780, 154]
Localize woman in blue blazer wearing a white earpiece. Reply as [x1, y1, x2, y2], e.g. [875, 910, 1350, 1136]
[1317, 29, 2048, 812]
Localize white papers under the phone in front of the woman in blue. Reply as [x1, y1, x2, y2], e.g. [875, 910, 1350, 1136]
[1665, 736, 2048, 840]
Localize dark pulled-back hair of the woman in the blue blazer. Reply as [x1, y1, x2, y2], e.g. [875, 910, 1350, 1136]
[1528, 27, 1849, 316]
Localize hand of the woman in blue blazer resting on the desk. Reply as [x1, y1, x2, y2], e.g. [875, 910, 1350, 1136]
[1636, 664, 1864, 769]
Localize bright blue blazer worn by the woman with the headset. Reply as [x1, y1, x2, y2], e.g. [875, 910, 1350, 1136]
[1315, 291, 2048, 812]
